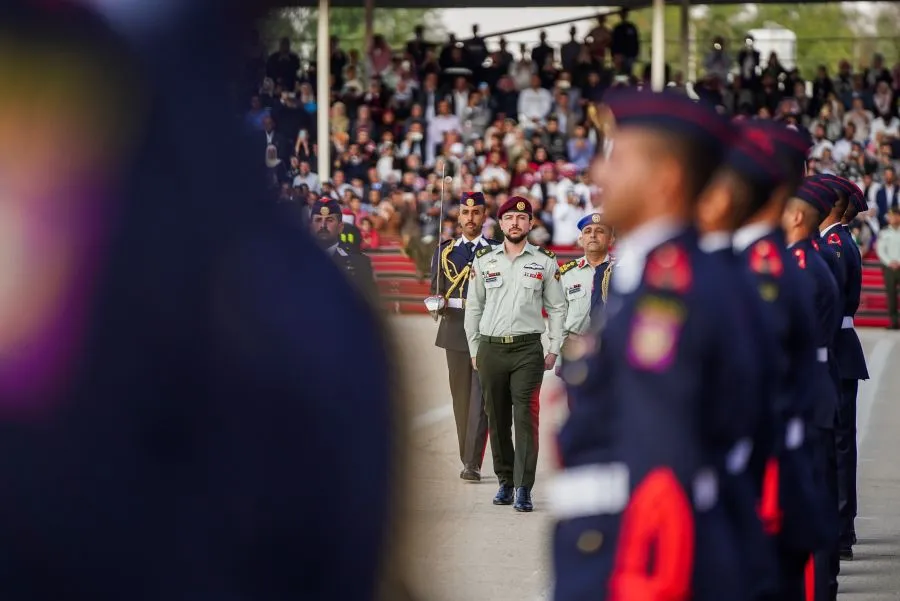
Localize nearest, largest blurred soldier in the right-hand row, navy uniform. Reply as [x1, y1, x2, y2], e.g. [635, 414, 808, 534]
[551, 90, 759, 601]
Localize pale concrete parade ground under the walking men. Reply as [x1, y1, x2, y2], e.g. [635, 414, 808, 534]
[391, 316, 900, 601]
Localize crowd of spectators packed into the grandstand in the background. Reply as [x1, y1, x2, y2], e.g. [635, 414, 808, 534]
[242, 11, 900, 270]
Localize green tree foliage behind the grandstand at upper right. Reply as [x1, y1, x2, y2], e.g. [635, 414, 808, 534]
[613, 3, 864, 77]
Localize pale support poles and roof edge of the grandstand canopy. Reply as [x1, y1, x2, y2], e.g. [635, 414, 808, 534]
[302, 0, 844, 181]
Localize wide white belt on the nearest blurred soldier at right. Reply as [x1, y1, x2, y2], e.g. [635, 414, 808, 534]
[547, 463, 630, 520]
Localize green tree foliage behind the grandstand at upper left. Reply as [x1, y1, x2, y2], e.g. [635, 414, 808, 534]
[260, 8, 445, 58]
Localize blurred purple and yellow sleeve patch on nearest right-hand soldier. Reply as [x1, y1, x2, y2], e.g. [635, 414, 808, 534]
[627, 296, 686, 372]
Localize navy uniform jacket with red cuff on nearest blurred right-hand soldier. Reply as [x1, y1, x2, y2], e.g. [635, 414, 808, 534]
[554, 230, 760, 601]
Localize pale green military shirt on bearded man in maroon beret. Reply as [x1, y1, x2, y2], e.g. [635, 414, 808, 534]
[465, 242, 566, 357]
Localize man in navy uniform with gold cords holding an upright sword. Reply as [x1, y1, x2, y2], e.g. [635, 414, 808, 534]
[431, 192, 498, 482]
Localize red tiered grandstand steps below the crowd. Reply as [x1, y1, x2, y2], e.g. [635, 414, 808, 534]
[367, 247, 888, 327]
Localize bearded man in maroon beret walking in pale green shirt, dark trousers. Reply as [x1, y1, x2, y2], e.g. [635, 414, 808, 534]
[465, 196, 566, 511]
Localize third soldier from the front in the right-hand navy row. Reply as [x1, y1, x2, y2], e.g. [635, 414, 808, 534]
[712, 121, 833, 600]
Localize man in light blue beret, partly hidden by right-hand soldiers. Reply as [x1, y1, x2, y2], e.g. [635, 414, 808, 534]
[557, 213, 615, 382]
